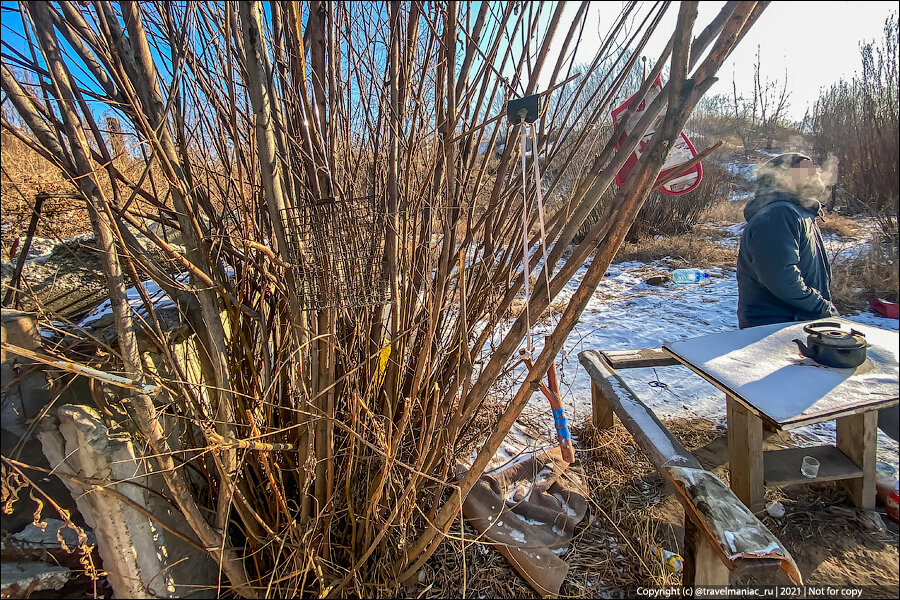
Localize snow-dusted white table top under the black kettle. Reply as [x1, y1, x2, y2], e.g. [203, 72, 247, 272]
[663, 317, 900, 429]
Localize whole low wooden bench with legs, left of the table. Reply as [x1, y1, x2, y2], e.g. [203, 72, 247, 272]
[578, 349, 802, 586]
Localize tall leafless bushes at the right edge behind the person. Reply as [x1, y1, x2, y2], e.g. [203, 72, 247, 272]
[808, 14, 900, 248]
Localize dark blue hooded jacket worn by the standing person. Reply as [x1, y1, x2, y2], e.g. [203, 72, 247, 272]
[737, 189, 838, 329]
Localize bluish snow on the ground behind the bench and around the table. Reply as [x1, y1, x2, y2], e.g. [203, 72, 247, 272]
[513, 221, 898, 474]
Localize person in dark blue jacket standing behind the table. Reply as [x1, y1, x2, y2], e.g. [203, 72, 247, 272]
[737, 152, 900, 440]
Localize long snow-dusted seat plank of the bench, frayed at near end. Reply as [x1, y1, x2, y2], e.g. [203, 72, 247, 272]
[578, 350, 801, 584]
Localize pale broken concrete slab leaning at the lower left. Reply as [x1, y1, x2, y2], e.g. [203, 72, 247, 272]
[38, 404, 218, 598]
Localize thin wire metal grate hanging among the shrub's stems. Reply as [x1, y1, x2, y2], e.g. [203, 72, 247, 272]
[283, 197, 390, 310]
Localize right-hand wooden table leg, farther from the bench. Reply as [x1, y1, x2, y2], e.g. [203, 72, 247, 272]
[836, 410, 878, 508]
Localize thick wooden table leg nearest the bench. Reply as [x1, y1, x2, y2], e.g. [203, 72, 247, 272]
[726, 395, 765, 512]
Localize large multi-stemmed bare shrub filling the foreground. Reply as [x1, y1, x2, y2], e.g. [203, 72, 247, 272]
[0, 1, 775, 596]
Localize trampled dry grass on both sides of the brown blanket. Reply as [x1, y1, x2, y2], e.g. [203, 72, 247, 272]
[416, 422, 684, 598]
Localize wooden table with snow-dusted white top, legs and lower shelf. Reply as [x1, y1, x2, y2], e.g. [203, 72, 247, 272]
[663, 318, 900, 511]
